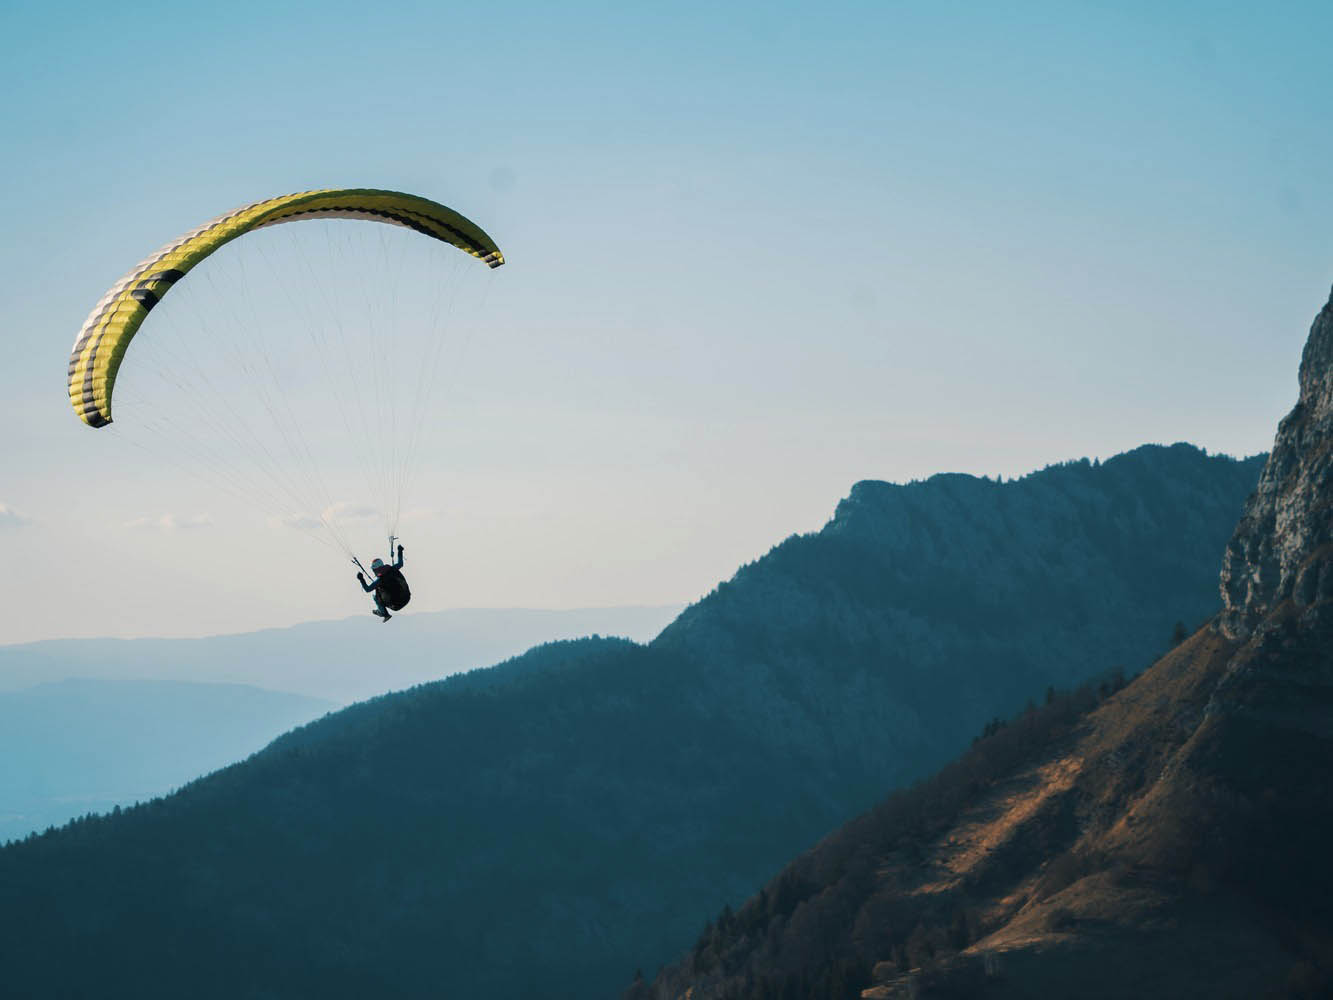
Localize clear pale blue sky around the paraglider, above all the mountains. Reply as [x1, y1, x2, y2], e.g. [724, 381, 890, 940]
[0, 1, 1333, 641]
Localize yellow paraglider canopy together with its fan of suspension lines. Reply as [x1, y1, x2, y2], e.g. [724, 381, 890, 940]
[68, 188, 504, 557]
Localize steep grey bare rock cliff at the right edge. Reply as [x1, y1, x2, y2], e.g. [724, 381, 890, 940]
[1221, 285, 1333, 639]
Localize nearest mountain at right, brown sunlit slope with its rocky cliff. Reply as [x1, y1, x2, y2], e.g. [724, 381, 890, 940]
[625, 289, 1333, 1000]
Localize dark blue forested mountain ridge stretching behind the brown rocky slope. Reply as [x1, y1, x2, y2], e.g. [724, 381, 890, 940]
[0, 445, 1258, 997]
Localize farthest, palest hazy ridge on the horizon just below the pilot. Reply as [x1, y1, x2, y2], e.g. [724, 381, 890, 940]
[0, 605, 680, 704]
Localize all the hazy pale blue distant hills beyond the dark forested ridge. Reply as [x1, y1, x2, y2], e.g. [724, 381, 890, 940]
[0, 605, 680, 843]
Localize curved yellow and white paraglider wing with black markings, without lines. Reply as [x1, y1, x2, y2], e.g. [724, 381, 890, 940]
[69, 188, 504, 427]
